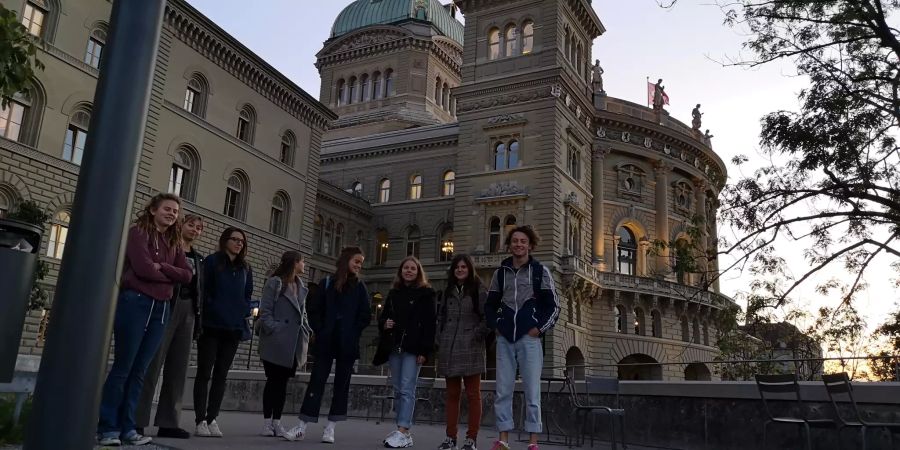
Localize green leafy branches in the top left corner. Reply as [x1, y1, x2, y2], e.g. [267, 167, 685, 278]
[0, 6, 44, 108]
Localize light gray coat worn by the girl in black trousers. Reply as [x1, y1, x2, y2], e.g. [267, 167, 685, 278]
[258, 277, 310, 367]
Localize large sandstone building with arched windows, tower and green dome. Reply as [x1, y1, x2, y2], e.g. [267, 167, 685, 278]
[7, 0, 731, 379]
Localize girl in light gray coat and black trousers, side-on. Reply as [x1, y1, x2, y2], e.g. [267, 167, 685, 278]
[259, 250, 310, 437]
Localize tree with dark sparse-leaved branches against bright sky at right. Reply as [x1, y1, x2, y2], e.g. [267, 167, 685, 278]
[721, 0, 900, 306]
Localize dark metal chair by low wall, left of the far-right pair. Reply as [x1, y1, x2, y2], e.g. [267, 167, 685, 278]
[756, 373, 841, 450]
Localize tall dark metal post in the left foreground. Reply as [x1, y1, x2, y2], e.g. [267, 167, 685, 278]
[24, 0, 165, 450]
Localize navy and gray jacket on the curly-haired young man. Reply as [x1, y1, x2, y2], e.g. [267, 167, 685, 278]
[484, 256, 559, 342]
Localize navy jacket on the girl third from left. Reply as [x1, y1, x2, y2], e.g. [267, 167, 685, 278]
[203, 252, 253, 331]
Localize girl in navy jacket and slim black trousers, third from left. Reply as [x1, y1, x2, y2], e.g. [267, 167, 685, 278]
[194, 227, 253, 437]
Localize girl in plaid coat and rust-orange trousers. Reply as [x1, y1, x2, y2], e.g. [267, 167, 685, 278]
[437, 254, 491, 450]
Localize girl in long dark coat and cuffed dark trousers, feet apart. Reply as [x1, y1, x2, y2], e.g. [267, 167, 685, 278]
[284, 247, 372, 443]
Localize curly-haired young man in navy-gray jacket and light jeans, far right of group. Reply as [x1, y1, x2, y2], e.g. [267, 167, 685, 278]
[485, 226, 559, 450]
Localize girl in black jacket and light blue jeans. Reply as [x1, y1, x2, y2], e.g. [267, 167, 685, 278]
[378, 256, 435, 448]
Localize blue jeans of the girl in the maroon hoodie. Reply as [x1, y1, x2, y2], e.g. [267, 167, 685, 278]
[97, 290, 169, 437]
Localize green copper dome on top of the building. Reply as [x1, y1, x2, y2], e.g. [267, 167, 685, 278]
[331, 0, 463, 45]
